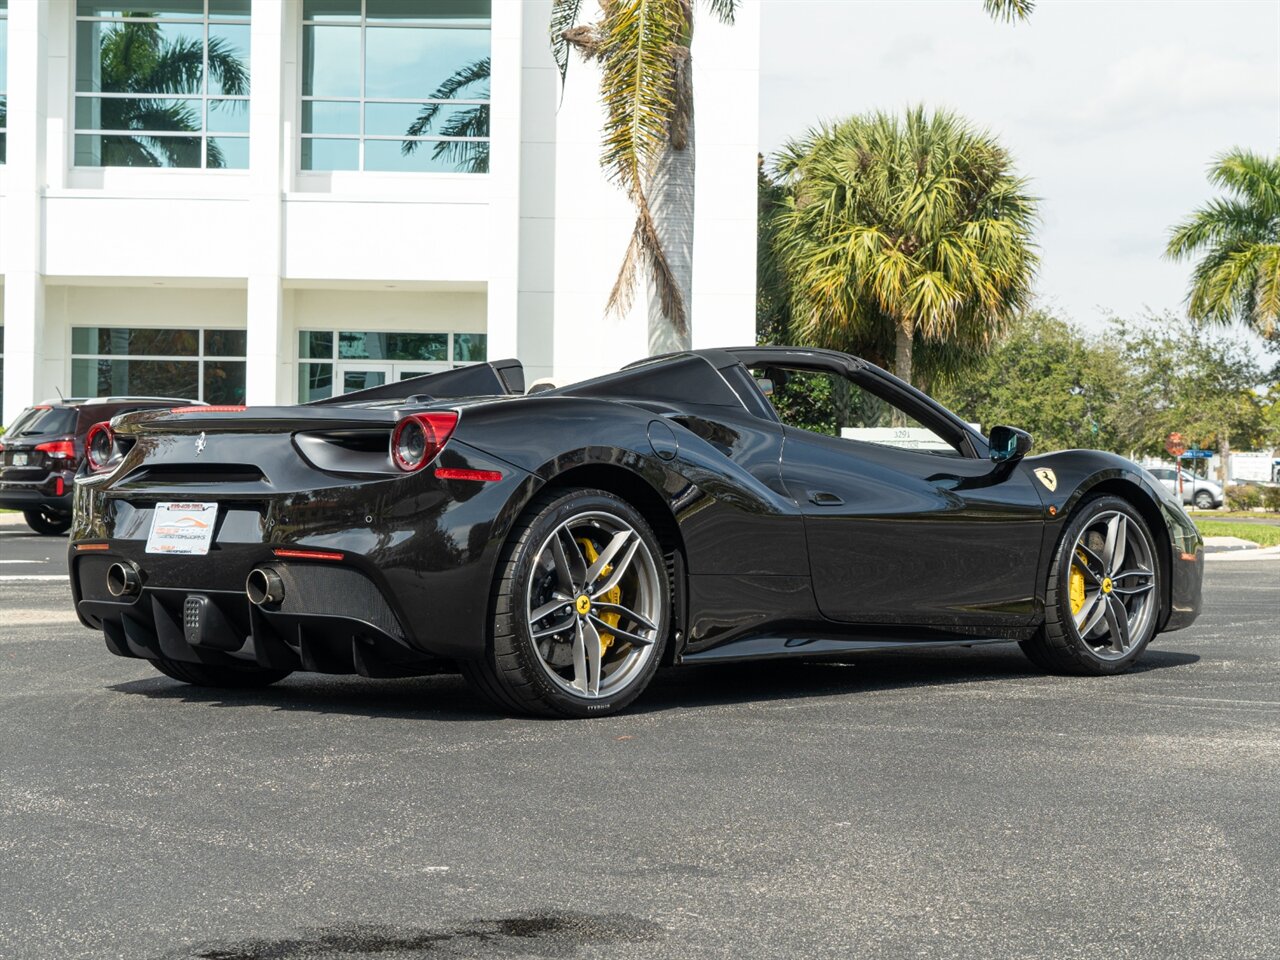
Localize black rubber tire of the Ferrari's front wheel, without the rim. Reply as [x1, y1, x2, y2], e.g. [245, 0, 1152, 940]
[1020, 497, 1164, 676]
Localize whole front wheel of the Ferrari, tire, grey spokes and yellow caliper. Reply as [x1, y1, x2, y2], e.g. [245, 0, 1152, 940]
[1021, 497, 1162, 675]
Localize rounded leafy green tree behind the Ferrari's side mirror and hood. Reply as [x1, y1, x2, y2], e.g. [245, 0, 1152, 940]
[936, 310, 1126, 452]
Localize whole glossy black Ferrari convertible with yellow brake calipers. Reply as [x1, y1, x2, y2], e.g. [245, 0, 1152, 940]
[69, 347, 1203, 717]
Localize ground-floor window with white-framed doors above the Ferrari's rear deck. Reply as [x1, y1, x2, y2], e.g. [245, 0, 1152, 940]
[298, 330, 488, 403]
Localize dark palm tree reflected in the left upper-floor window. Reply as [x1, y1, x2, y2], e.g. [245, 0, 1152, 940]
[85, 22, 248, 166]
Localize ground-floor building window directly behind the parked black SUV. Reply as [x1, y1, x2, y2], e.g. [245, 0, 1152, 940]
[72, 326, 247, 403]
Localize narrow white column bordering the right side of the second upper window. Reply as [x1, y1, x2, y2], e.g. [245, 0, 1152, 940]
[485, 0, 522, 360]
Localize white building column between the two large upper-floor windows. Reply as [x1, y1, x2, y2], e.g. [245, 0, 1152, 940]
[243, 0, 286, 404]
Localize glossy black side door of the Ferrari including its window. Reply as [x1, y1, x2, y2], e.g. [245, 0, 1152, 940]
[758, 369, 1044, 628]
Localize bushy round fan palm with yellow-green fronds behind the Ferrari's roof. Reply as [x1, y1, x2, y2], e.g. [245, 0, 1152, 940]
[774, 108, 1038, 383]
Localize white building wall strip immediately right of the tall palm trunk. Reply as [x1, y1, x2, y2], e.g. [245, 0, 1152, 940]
[690, 0, 760, 348]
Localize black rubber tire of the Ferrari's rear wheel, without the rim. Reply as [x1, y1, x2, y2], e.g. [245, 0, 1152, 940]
[460, 488, 671, 717]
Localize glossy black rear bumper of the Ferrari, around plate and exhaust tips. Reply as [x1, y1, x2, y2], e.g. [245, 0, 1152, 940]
[68, 443, 536, 676]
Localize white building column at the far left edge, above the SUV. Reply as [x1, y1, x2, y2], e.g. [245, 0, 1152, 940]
[0, 0, 49, 422]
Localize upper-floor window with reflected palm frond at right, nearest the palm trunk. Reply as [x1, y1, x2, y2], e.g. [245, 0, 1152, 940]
[301, 0, 490, 173]
